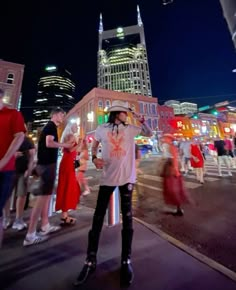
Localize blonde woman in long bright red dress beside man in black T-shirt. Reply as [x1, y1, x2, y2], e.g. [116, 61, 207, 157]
[56, 123, 80, 225]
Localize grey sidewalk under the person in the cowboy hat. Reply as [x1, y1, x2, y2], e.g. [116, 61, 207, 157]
[0, 207, 236, 290]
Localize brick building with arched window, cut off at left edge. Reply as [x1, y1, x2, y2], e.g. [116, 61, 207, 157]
[0, 59, 24, 109]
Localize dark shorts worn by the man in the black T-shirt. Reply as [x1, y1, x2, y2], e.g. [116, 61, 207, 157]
[32, 163, 56, 196]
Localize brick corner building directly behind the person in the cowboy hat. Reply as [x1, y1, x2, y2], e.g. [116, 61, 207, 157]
[66, 88, 158, 140]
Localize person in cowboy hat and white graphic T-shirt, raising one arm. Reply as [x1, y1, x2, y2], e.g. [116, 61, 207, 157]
[74, 101, 152, 286]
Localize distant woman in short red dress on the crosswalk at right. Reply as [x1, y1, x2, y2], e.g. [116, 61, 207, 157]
[190, 140, 204, 184]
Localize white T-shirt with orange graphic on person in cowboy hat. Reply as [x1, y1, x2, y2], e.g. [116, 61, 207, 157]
[95, 123, 141, 186]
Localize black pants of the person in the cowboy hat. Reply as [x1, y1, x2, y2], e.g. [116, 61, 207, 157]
[87, 183, 134, 261]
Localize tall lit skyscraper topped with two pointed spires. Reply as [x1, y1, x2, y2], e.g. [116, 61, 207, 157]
[98, 6, 152, 97]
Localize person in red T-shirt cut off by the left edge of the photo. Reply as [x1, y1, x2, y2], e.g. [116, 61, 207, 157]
[0, 89, 25, 247]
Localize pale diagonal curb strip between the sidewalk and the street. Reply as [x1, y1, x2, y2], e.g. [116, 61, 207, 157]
[133, 217, 236, 282]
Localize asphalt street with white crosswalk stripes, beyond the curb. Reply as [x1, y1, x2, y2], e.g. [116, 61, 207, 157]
[81, 156, 236, 272]
